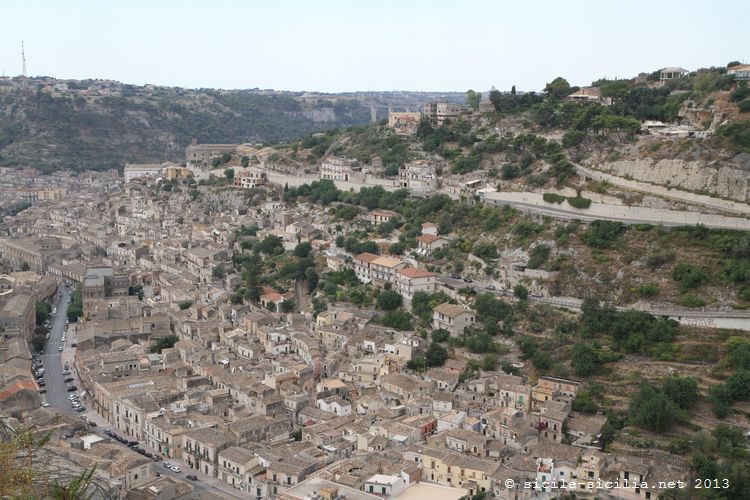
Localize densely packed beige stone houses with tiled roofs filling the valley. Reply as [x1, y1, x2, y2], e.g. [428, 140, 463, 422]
[0, 94, 712, 500]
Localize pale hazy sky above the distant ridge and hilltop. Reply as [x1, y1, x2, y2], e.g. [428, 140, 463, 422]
[0, 0, 750, 91]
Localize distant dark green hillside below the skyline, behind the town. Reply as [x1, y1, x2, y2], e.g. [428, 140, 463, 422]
[0, 78, 464, 171]
